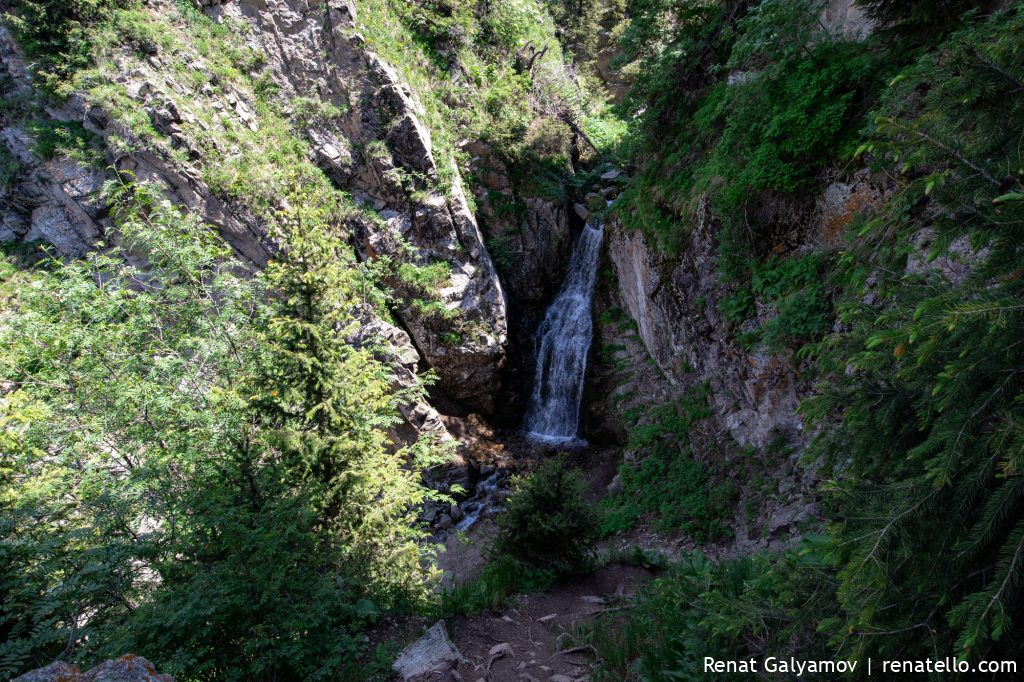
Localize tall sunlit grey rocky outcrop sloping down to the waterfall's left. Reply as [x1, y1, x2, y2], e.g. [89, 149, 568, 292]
[211, 0, 508, 412]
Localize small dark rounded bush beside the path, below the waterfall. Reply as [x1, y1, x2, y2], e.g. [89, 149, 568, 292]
[495, 456, 597, 574]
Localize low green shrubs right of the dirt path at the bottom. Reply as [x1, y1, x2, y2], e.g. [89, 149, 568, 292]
[585, 543, 836, 682]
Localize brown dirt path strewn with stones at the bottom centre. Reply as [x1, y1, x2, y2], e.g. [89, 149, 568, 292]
[451, 564, 651, 682]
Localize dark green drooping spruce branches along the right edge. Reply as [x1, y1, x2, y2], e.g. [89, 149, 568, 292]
[805, 3, 1024, 658]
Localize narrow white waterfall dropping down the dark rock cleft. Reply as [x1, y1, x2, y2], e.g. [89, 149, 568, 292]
[525, 219, 604, 442]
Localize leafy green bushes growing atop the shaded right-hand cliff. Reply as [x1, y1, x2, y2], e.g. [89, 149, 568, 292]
[620, 0, 884, 254]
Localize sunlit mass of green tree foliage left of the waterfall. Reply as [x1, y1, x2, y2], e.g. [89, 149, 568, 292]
[0, 183, 440, 680]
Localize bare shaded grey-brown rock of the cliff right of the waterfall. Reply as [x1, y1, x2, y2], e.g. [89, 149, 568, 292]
[607, 170, 891, 449]
